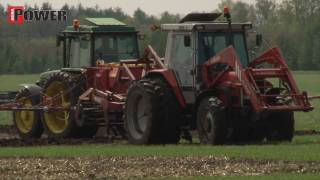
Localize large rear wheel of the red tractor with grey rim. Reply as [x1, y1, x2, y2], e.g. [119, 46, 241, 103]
[124, 79, 180, 144]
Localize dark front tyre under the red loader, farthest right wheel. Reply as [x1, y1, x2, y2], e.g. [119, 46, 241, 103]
[267, 112, 294, 141]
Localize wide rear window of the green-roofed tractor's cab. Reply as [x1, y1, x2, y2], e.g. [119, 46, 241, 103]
[94, 34, 138, 63]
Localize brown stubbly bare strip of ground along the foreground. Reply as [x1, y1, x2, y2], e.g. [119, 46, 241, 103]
[0, 156, 320, 179]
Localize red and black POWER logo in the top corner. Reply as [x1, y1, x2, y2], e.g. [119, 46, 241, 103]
[7, 6, 67, 25]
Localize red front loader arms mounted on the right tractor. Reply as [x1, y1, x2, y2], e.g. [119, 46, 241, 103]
[202, 46, 313, 112]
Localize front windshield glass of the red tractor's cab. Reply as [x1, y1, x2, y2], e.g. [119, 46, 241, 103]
[199, 32, 248, 67]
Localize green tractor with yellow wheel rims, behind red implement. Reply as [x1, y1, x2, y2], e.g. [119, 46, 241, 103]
[12, 18, 139, 139]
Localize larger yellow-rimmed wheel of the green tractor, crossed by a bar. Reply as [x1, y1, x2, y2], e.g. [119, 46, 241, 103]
[43, 72, 83, 139]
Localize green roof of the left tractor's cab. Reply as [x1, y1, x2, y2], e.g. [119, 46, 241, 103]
[63, 18, 137, 33]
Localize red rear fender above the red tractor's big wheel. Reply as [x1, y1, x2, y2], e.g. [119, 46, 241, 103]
[145, 69, 186, 108]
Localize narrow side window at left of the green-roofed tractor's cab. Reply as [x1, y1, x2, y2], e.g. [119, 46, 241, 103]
[67, 35, 91, 68]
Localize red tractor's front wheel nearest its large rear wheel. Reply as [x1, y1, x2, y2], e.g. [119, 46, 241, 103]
[197, 97, 227, 145]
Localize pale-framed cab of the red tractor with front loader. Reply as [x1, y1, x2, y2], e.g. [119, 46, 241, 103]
[161, 13, 252, 102]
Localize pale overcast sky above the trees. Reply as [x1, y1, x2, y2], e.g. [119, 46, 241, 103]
[1, 0, 264, 15]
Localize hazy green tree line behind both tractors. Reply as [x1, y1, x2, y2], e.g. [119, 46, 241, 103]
[0, 0, 320, 74]
